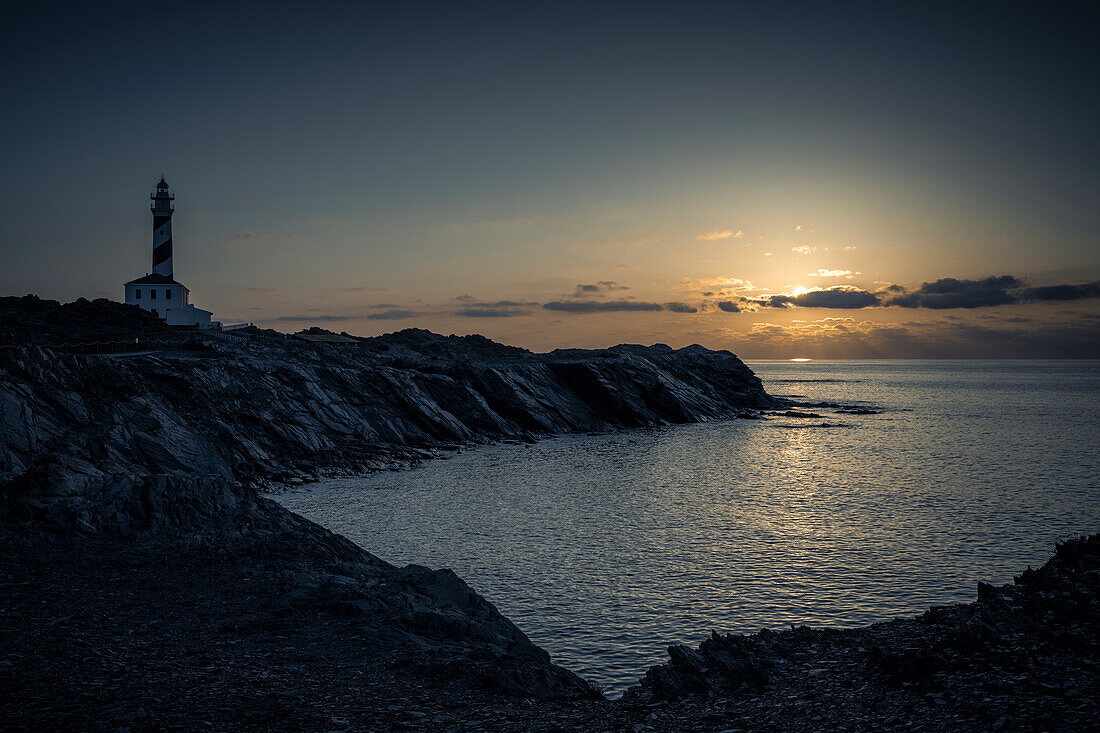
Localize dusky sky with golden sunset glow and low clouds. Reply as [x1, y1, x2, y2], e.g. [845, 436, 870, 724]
[0, 2, 1100, 359]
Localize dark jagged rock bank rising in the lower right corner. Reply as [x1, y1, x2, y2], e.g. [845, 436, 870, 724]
[624, 535, 1100, 731]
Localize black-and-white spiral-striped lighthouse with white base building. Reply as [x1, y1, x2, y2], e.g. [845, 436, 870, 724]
[123, 176, 219, 328]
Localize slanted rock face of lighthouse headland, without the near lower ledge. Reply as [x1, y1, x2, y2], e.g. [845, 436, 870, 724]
[0, 299, 776, 532]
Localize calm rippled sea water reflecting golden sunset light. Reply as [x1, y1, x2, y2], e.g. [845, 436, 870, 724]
[278, 361, 1100, 693]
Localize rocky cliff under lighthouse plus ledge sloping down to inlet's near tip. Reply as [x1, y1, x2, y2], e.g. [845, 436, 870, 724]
[0, 298, 778, 696]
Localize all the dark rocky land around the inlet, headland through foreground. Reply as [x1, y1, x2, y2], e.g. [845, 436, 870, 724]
[0, 298, 1100, 731]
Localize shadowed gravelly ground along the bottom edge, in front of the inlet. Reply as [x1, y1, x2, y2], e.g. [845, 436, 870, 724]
[0, 527, 1100, 733]
